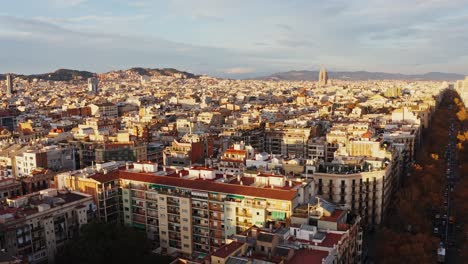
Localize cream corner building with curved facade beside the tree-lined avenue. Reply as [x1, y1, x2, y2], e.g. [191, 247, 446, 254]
[312, 154, 403, 225]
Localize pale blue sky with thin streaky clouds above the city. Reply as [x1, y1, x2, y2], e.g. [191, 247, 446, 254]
[0, 0, 468, 78]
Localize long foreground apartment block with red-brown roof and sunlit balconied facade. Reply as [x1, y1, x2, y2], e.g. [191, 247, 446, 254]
[58, 163, 315, 256]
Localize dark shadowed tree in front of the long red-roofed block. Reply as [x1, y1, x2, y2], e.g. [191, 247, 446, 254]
[56, 223, 171, 264]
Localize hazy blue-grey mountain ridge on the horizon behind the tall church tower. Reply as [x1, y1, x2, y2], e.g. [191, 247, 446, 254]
[255, 71, 465, 81]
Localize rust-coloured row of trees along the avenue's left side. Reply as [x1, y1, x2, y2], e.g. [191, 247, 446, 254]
[376, 91, 455, 263]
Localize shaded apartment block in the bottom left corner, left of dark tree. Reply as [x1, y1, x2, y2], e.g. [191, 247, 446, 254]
[0, 189, 94, 263]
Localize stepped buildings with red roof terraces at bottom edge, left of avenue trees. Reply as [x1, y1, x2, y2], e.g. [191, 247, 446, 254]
[207, 199, 363, 264]
